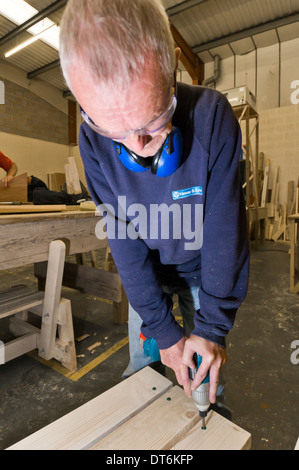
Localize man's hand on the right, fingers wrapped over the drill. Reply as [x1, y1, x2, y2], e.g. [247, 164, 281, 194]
[180, 335, 227, 403]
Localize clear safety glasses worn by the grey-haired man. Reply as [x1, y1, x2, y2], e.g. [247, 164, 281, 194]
[81, 95, 177, 140]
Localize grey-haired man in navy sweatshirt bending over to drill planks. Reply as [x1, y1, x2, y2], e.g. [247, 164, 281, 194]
[60, 0, 249, 403]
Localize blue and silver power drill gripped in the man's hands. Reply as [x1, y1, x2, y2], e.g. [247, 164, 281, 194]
[189, 353, 210, 429]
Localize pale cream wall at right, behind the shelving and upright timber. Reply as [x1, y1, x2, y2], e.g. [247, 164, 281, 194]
[192, 38, 299, 204]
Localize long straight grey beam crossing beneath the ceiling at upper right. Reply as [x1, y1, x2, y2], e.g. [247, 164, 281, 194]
[192, 12, 299, 54]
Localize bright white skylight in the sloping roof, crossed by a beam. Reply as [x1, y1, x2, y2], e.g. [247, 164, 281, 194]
[0, 0, 59, 51]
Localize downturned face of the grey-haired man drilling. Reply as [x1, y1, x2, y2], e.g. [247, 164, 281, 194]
[70, 61, 173, 157]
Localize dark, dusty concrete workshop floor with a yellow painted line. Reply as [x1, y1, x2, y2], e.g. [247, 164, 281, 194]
[0, 242, 299, 450]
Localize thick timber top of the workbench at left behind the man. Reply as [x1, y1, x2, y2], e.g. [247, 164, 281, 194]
[0, 206, 107, 269]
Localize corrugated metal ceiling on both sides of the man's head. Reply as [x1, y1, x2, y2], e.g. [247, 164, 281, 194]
[0, 0, 299, 95]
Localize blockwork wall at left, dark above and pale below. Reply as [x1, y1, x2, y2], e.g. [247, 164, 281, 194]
[0, 59, 86, 185]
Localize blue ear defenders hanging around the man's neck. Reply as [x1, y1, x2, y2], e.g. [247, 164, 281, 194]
[113, 127, 183, 177]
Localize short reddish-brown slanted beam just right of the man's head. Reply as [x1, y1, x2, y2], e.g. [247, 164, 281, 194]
[170, 24, 204, 85]
